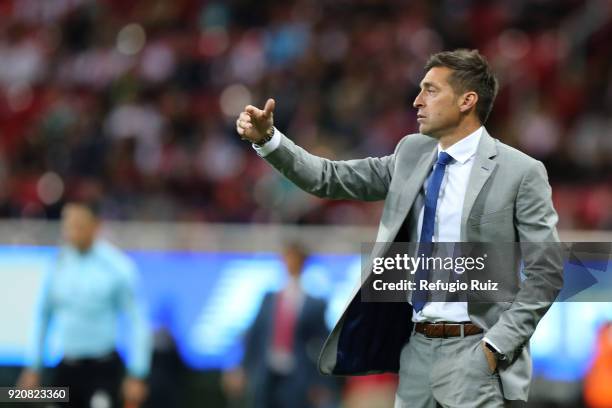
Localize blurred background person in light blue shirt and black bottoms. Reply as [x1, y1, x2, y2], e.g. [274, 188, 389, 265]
[18, 203, 151, 408]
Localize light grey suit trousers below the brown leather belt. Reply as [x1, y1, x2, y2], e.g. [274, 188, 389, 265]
[395, 332, 510, 408]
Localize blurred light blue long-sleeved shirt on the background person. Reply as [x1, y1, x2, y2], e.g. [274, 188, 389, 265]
[31, 240, 151, 378]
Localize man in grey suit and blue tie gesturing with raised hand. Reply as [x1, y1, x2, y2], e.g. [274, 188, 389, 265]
[236, 50, 563, 407]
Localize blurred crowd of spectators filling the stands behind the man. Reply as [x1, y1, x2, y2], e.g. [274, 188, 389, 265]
[0, 0, 612, 229]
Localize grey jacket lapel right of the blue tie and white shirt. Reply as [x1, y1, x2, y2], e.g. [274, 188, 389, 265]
[461, 129, 497, 241]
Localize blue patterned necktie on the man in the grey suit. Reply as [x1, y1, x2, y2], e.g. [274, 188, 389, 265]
[412, 152, 453, 312]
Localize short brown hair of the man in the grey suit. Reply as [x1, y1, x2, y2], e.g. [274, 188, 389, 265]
[425, 48, 499, 125]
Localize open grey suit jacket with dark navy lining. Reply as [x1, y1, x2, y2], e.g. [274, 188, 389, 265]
[265, 131, 563, 400]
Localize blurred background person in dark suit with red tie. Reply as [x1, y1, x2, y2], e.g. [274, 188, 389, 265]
[222, 244, 335, 408]
